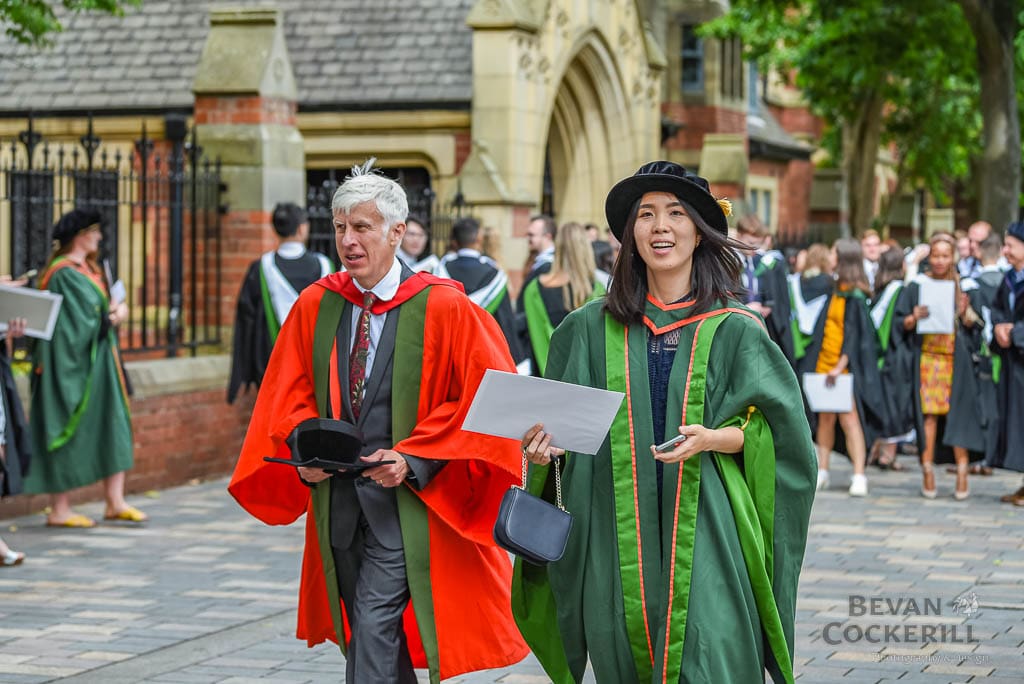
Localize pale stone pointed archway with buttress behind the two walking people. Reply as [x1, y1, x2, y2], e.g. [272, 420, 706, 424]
[459, 0, 666, 268]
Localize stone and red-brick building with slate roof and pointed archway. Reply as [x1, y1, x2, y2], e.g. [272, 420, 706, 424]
[0, 0, 847, 517]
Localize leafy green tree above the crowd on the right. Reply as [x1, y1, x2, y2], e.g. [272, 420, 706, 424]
[706, 0, 1003, 230]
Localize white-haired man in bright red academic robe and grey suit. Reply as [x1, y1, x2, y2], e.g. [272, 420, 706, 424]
[228, 164, 527, 684]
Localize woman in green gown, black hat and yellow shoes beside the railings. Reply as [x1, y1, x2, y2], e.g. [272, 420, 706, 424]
[25, 209, 146, 527]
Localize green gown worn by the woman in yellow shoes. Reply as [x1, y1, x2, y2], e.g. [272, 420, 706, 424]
[25, 257, 132, 494]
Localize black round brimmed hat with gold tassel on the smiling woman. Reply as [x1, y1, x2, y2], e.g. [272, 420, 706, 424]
[604, 162, 731, 241]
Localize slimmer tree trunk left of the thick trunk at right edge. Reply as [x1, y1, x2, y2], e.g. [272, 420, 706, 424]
[841, 90, 885, 238]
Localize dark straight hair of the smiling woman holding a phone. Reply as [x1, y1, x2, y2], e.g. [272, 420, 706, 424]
[604, 198, 746, 326]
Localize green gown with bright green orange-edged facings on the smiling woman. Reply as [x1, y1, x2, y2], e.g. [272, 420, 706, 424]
[513, 298, 817, 684]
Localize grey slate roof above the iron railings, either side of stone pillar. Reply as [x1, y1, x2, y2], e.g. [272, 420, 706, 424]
[0, 0, 474, 116]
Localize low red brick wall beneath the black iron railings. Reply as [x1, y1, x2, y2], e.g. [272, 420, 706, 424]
[0, 379, 256, 519]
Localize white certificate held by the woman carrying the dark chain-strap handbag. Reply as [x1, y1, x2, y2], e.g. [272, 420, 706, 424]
[462, 370, 625, 454]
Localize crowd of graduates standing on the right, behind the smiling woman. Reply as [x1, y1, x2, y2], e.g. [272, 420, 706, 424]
[737, 217, 1024, 506]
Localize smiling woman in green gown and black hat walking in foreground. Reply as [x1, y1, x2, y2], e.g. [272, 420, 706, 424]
[513, 162, 816, 684]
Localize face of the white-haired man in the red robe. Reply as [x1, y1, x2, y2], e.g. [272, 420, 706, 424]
[334, 201, 406, 289]
